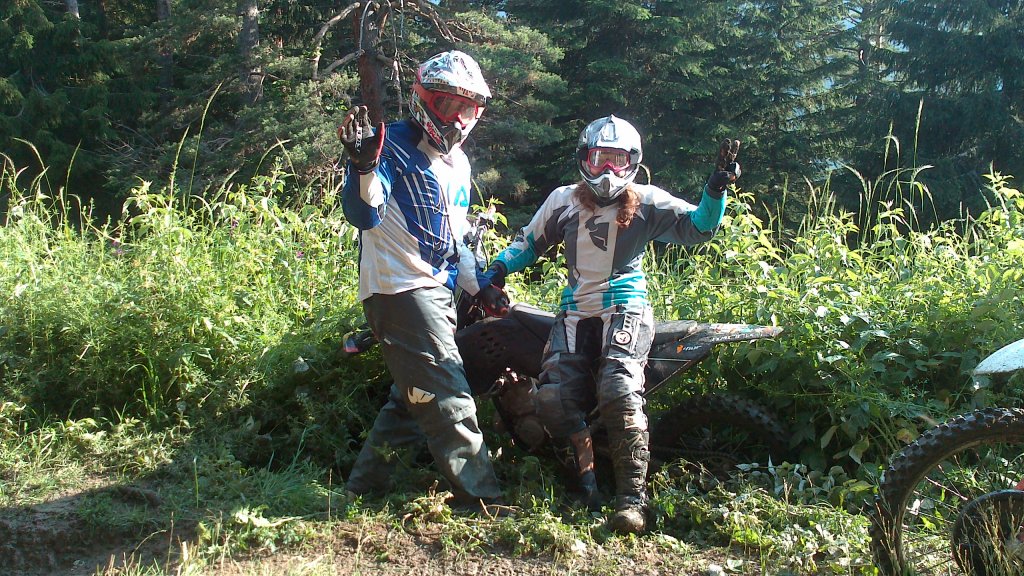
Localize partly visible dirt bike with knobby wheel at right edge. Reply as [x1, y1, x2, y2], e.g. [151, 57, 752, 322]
[870, 339, 1024, 576]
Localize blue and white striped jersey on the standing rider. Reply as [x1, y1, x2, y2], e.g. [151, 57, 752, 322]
[342, 120, 476, 300]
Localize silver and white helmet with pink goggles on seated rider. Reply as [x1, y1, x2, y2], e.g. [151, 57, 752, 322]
[577, 116, 643, 200]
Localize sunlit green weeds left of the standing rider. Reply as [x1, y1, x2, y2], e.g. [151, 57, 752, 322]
[0, 155, 381, 467]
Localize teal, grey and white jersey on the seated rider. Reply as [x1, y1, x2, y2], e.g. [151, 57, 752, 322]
[497, 184, 725, 313]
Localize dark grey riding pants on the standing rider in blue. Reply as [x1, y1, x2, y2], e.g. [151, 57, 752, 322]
[347, 286, 501, 501]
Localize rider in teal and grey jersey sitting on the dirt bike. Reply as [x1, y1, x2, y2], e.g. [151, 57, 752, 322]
[481, 116, 740, 533]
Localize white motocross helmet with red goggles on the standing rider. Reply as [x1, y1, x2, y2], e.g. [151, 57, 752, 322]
[410, 50, 490, 154]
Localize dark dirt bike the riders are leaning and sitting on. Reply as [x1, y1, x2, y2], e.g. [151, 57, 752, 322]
[345, 206, 788, 476]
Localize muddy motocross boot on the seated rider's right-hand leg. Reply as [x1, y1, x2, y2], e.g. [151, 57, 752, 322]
[608, 428, 650, 534]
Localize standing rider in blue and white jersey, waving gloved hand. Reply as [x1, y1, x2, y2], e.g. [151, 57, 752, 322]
[338, 50, 501, 506]
